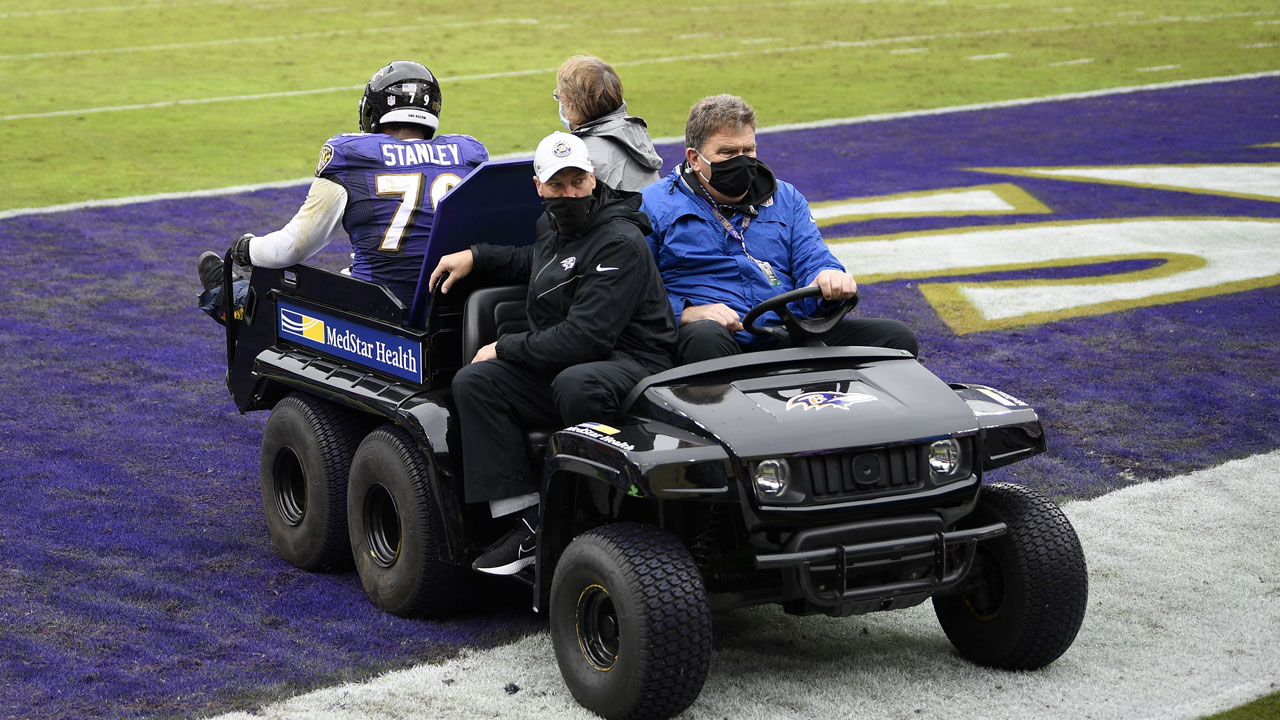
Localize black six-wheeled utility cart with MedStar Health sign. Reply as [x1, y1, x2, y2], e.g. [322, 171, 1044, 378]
[224, 161, 1088, 719]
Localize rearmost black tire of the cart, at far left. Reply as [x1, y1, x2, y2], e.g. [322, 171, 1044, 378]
[259, 393, 369, 570]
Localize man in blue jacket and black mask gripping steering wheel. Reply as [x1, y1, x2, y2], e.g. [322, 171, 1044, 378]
[641, 95, 916, 363]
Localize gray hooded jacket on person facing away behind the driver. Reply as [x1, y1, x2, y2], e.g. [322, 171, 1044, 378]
[573, 102, 662, 192]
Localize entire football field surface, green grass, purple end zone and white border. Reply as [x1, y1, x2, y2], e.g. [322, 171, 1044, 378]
[0, 0, 1280, 719]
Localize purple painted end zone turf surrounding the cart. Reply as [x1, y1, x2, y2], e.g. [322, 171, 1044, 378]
[0, 79, 1280, 717]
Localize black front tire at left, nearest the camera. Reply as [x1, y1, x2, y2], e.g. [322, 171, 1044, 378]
[550, 523, 712, 720]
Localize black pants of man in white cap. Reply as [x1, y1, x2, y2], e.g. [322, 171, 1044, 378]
[453, 356, 652, 502]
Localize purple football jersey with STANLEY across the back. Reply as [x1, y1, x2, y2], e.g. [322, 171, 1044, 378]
[316, 133, 489, 304]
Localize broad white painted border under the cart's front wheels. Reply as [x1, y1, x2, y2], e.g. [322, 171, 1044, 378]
[209, 451, 1280, 720]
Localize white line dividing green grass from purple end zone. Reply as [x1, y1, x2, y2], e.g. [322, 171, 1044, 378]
[0, 70, 1280, 220]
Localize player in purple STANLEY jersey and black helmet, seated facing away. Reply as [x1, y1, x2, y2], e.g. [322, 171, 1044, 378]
[198, 60, 489, 322]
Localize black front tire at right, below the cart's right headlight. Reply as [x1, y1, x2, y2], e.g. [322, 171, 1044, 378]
[933, 483, 1089, 670]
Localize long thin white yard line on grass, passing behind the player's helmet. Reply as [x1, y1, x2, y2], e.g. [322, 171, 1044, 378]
[0, 10, 1280, 122]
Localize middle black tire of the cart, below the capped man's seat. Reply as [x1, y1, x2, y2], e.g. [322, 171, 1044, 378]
[347, 425, 466, 618]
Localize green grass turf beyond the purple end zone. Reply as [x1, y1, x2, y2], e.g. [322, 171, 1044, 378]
[0, 0, 1280, 210]
